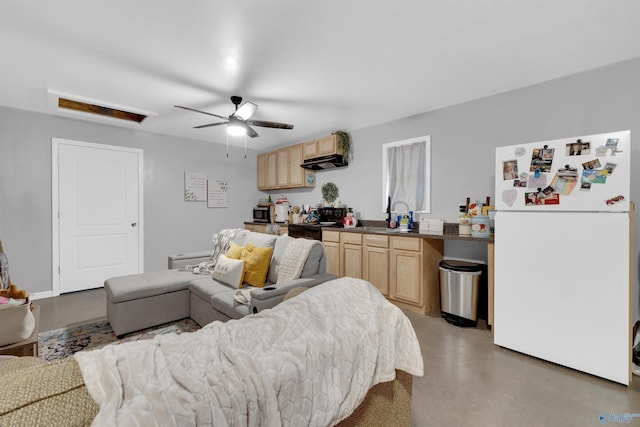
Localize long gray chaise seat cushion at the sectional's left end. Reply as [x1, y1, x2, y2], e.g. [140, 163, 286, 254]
[104, 270, 198, 304]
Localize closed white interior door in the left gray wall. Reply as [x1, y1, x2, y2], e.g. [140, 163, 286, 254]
[53, 139, 142, 294]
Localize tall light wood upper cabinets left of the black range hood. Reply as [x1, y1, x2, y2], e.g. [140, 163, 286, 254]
[257, 144, 316, 190]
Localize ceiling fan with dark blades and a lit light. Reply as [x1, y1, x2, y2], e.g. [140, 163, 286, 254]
[174, 96, 293, 138]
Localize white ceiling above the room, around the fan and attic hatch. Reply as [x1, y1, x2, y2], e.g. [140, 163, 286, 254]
[0, 0, 640, 150]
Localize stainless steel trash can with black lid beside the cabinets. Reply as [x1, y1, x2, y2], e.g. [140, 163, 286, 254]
[440, 259, 482, 327]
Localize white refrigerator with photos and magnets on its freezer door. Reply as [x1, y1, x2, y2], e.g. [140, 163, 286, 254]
[493, 131, 633, 385]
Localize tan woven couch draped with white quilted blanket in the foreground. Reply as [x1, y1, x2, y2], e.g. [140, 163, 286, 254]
[0, 278, 423, 426]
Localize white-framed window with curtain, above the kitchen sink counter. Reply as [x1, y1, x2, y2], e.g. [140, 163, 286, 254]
[382, 135, 431, 213]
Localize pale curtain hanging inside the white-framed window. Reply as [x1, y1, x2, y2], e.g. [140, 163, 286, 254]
[387, 142, 426, 212]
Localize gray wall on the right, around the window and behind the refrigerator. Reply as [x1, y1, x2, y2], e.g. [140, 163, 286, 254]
[282, 58, 640, 318]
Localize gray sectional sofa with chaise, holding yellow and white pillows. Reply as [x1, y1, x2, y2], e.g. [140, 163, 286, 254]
[104, 230, 336, 336]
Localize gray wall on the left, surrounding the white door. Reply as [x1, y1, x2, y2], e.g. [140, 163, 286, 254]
[0, 107, 260, 293]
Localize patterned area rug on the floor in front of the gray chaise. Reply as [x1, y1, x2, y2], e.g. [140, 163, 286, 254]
[38, 318, 200, 360]
